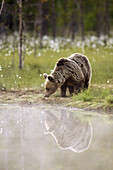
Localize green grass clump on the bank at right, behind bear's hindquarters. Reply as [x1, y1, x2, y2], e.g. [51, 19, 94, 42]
[67, 85, 113, 113]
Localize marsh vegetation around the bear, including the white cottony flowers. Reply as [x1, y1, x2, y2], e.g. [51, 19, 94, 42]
[0, 34, 113, 111]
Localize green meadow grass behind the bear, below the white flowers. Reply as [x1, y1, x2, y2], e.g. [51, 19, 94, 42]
[0, 47, 113, 89]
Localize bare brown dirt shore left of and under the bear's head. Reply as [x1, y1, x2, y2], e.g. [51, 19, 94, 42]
[0, 90, 72, 106]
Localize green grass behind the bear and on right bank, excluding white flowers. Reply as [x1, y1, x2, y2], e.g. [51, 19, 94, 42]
[0, 37, 113, 111]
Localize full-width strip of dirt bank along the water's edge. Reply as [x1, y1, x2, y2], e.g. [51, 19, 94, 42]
[0, 89, 113, 114]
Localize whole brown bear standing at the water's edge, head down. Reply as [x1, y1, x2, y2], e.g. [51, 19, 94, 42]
[43, 53, 92, 97]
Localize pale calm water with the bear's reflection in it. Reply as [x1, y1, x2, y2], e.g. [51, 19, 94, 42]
[0, 105, 113, 170]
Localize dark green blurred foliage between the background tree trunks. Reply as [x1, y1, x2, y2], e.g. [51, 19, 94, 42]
[0, 0, 113, 36]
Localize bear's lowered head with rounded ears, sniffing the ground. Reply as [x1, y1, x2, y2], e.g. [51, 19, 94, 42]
[43, 73, 58, 97]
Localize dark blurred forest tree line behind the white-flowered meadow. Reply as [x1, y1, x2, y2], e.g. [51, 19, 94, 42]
[0, 0, 113, 38]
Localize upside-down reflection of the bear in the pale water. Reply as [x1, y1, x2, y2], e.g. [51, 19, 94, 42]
[45, 111, 92, 152]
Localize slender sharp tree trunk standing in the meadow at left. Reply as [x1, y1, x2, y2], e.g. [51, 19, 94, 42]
[19, 0, 22, 69]
